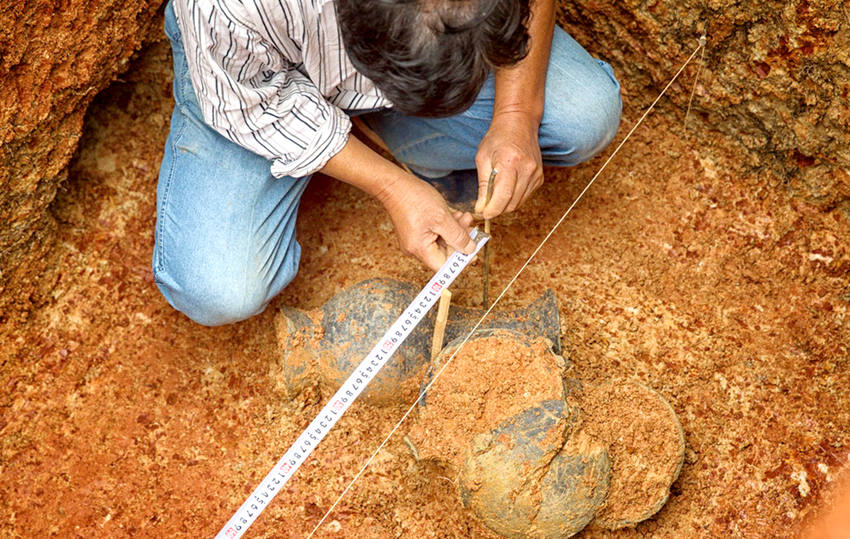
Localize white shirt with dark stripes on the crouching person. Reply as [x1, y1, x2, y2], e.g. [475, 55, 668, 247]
[173, 0, 391, 177]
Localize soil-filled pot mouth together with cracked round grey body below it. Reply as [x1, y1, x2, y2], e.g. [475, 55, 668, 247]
[410, 330, 609, 537]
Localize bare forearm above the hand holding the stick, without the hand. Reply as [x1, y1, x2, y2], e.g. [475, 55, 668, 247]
[486, 0, 555, 124]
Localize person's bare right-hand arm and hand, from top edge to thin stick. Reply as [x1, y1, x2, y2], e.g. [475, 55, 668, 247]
[475, 0, 555, 218]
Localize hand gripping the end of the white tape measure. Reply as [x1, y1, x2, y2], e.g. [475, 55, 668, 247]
[378, 175, 475, 271]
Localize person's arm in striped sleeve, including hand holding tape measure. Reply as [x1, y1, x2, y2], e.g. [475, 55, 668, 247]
[174, 1, 474, 269]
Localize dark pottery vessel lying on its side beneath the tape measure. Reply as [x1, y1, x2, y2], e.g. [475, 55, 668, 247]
[275, 279, 560, 402]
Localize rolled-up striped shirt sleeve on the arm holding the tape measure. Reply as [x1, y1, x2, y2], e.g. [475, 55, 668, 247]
[172, 0, 351, 177]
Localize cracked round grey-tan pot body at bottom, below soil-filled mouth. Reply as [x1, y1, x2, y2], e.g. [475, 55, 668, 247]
[459, 400, 610, 537]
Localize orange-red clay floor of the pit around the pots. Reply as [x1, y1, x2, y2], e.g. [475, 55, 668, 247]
[0, 40, 850, 538]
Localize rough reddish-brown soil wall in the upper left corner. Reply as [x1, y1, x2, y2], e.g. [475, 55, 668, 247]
[0, 0, 162, 321]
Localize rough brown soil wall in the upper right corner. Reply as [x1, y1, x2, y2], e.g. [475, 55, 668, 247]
[558, 0, 850, 207]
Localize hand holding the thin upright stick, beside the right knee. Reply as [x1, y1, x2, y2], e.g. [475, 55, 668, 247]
[475, 112, 543, 219]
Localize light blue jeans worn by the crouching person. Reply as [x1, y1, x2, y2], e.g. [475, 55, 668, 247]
[153, 4, 621, 326]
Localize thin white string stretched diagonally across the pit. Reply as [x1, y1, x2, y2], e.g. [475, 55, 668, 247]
[307, 39, 703, 539]
